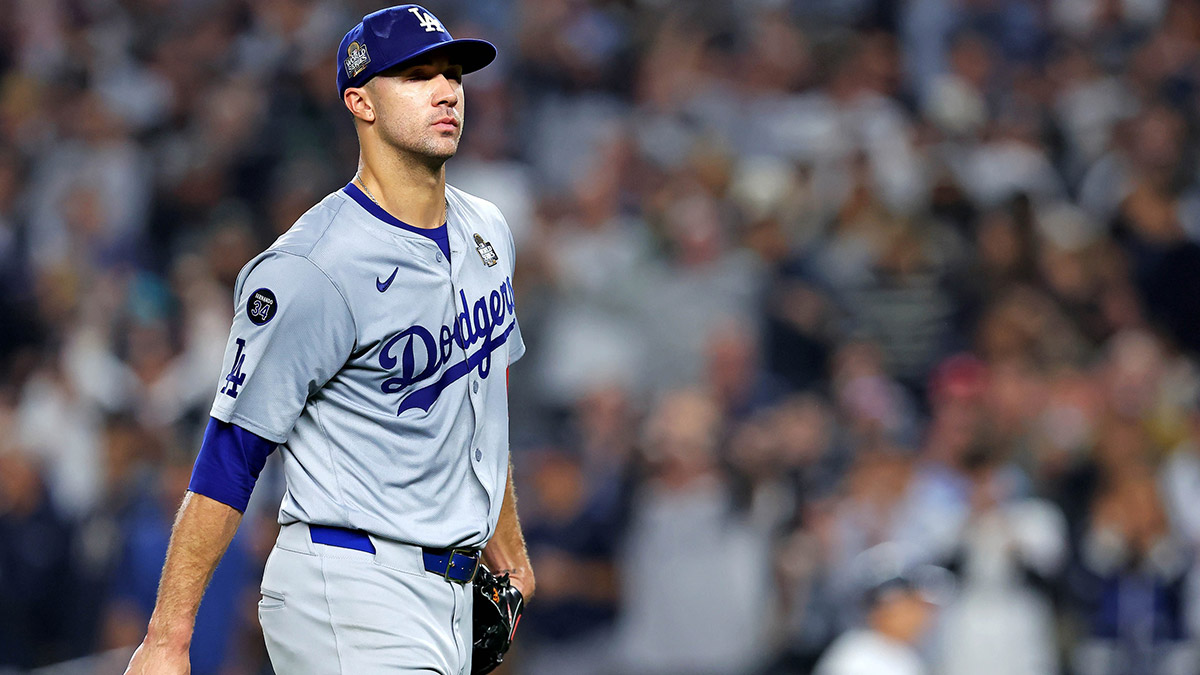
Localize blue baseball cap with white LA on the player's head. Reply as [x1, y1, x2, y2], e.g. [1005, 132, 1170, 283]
[337, 5, 496, 95]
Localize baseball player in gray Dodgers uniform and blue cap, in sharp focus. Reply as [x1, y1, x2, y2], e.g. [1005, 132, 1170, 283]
[127, 5, 534, 675]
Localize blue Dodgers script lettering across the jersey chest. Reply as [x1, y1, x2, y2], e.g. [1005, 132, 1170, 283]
[379, 279, 517, 414]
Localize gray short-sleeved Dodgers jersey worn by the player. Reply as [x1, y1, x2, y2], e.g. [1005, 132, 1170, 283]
[211, 186, 524, 548]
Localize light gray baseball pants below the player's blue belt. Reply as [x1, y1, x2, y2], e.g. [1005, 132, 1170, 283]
[258, 524, 474, 675]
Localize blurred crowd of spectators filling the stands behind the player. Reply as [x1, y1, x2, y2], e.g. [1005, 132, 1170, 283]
[7, 0, 1200, 675]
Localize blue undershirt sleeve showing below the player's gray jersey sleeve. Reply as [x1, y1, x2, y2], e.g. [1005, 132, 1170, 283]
[187, 418, 275, 513]
